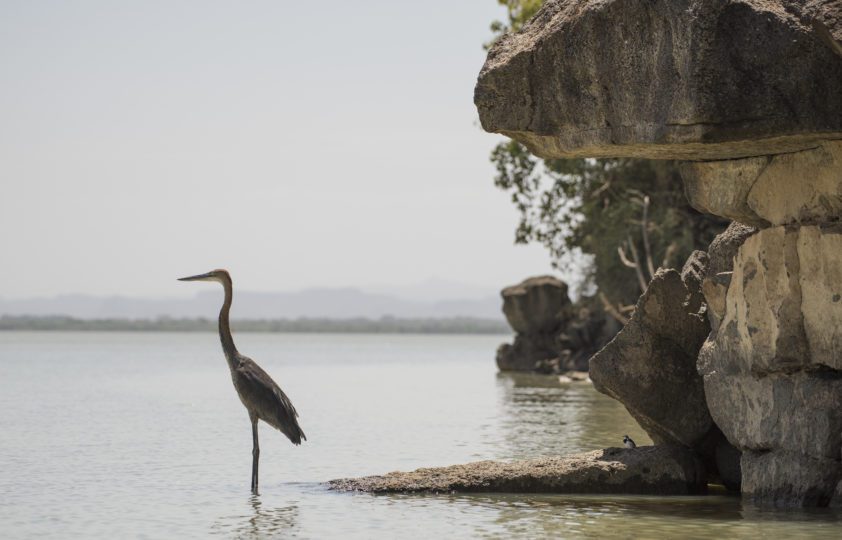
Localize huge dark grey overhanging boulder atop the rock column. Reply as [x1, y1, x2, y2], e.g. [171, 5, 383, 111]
[474, 0, 842, 159]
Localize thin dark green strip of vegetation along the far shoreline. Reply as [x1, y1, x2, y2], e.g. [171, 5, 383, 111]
[0, 315, 512, 334]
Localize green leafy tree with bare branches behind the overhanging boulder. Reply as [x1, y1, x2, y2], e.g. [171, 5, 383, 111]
[486, 0, 727, 311]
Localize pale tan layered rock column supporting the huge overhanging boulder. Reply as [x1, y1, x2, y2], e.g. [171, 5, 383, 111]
[683, 142, 842, 506]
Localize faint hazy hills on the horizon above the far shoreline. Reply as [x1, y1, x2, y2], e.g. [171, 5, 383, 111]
[0, 288, 503, 320]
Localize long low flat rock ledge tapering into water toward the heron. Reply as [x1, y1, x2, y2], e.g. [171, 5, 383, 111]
[328, 446, 707, 495]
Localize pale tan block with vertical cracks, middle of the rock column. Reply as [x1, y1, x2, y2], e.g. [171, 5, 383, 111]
[704, 225, 842, 376]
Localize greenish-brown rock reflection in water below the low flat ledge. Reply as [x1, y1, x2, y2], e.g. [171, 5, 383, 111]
[426, 494, 840, 538]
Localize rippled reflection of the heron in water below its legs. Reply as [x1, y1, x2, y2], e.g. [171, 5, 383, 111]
[211, 495, 299, 538]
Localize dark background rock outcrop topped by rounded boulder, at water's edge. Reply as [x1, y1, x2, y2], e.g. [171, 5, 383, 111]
[497, 276, 619, 373]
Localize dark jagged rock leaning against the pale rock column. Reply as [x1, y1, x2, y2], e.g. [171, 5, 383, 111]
[590, 247, 740, 490]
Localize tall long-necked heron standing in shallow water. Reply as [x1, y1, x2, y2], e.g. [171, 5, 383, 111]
[179, 270, 307, 495]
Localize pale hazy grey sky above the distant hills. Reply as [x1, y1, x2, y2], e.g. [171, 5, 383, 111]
[0, 0, 550, 298]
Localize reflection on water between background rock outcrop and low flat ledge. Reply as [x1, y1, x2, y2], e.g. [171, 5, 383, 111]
[497, 373, 651, 458]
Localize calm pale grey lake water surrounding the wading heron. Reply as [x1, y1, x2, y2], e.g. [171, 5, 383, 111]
[0, 332, 842, 538]
